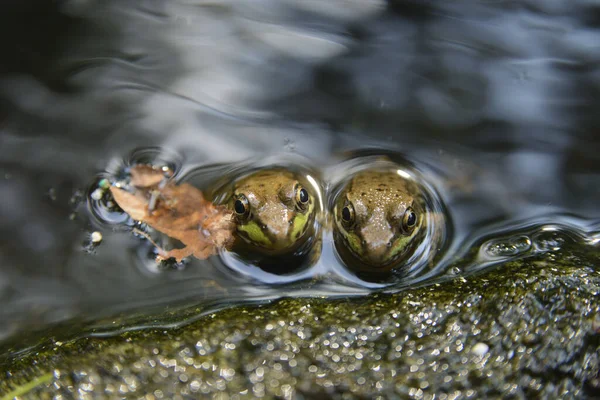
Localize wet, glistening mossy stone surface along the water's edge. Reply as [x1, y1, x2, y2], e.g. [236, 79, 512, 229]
[0, 251, 600, 399]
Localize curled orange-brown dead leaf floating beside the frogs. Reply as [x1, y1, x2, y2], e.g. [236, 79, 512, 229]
[110, 165, 235, 261]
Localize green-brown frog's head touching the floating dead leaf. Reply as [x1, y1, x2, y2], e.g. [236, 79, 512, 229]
[216, 167, 317, 258]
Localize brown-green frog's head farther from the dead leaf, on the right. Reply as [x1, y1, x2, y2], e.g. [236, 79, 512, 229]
[332, 168, 427, 274]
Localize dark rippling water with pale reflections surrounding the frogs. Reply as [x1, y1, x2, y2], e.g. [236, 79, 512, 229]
[0, 0, 600, 352]
